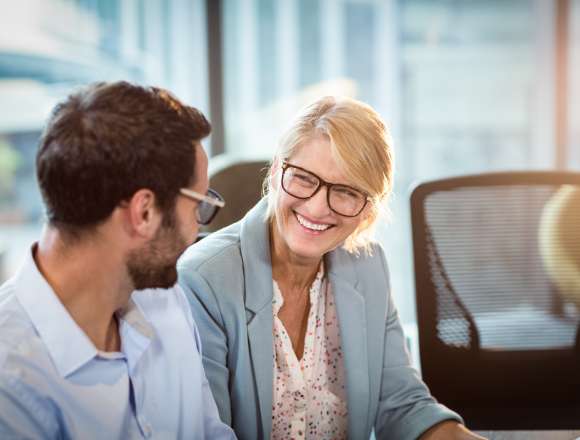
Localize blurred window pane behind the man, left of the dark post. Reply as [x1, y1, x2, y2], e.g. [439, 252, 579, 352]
[0, 0, 208, 282]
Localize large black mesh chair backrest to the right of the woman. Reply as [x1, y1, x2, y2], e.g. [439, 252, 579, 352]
[411, 172, 580, 429]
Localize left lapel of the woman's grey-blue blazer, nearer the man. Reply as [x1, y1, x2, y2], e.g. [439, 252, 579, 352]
[240, 199, 274, 438]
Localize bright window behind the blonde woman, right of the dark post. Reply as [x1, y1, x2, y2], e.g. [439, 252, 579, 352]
[223, 0, 580, 322]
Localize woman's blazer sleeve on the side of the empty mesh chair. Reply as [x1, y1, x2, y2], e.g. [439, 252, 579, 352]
[375, 249, 463, 440]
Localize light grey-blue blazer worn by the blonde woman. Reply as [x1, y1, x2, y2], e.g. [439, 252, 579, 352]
[178, 200, 461, 440]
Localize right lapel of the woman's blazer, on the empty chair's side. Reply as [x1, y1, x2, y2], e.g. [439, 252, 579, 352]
[327, 250, 370, 439]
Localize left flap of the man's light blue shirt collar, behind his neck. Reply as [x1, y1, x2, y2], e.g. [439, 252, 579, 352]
[16, 244, 97, 377]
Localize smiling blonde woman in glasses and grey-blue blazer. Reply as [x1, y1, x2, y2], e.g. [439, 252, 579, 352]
[179, 97, 479, 440]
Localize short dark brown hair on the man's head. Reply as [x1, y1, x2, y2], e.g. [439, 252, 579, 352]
[36, 82, 211, 232]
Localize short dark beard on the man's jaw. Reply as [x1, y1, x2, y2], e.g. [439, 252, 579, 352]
[127, 215, 187, 290]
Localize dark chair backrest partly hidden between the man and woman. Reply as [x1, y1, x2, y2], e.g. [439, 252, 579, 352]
[203, 154, 269, 232]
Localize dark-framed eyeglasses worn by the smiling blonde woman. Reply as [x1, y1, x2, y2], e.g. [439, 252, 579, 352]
[282, 161, 369, 217]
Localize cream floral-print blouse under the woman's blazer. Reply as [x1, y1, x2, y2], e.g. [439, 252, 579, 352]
[271, 265, 348, 439]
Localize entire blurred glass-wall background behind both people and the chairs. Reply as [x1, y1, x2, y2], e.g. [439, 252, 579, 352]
[0, 0, 580, 324]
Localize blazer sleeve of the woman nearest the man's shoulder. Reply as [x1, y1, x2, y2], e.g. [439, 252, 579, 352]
[179, 270, 232, 426]
